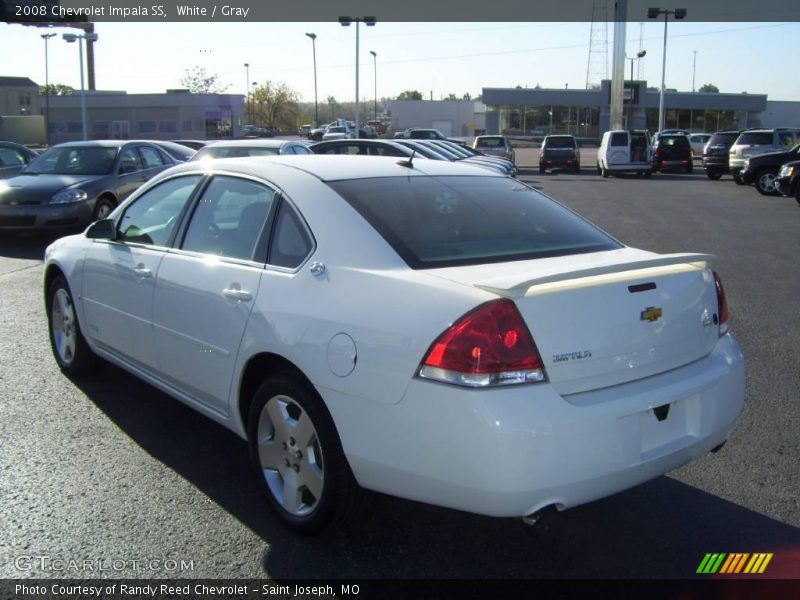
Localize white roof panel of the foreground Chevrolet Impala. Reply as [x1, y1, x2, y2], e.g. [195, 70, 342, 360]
[162, 154, 502, 181]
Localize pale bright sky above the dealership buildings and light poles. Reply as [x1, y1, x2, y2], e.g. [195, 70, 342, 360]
[0, 20, 800, 103]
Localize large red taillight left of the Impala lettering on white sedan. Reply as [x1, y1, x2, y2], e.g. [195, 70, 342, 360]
[419, 299, 545, 387]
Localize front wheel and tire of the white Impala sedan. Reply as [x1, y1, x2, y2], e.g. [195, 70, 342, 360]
[46, 275, 97, 376]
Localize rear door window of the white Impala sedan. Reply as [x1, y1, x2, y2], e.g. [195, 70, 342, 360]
[181, 177, 276, 260]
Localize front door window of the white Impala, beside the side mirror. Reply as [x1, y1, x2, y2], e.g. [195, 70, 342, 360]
[117, 175, 202, 246]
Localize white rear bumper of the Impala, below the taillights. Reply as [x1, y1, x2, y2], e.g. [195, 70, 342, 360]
[320, 335, 745, 517]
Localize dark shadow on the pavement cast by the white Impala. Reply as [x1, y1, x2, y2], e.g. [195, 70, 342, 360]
[74, 364, 800, 581]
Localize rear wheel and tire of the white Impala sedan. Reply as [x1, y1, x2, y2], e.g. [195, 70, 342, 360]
[247, 373, 363, 535]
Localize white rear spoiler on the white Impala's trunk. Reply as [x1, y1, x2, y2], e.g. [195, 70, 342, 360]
[474, 253, 717, 298]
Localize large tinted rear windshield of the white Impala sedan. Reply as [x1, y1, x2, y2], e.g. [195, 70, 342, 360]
[328, 176, 621, 269]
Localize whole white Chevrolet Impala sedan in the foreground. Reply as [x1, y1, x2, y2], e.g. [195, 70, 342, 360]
[44, 155, 745, 532]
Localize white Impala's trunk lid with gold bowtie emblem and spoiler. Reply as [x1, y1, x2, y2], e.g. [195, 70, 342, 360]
[428, 248, 719, 395]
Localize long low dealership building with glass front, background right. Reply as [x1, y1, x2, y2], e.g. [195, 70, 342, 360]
[389, 80, 800, 139]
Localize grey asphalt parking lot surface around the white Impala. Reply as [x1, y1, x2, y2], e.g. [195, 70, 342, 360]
[0, 154, 800, 579]
